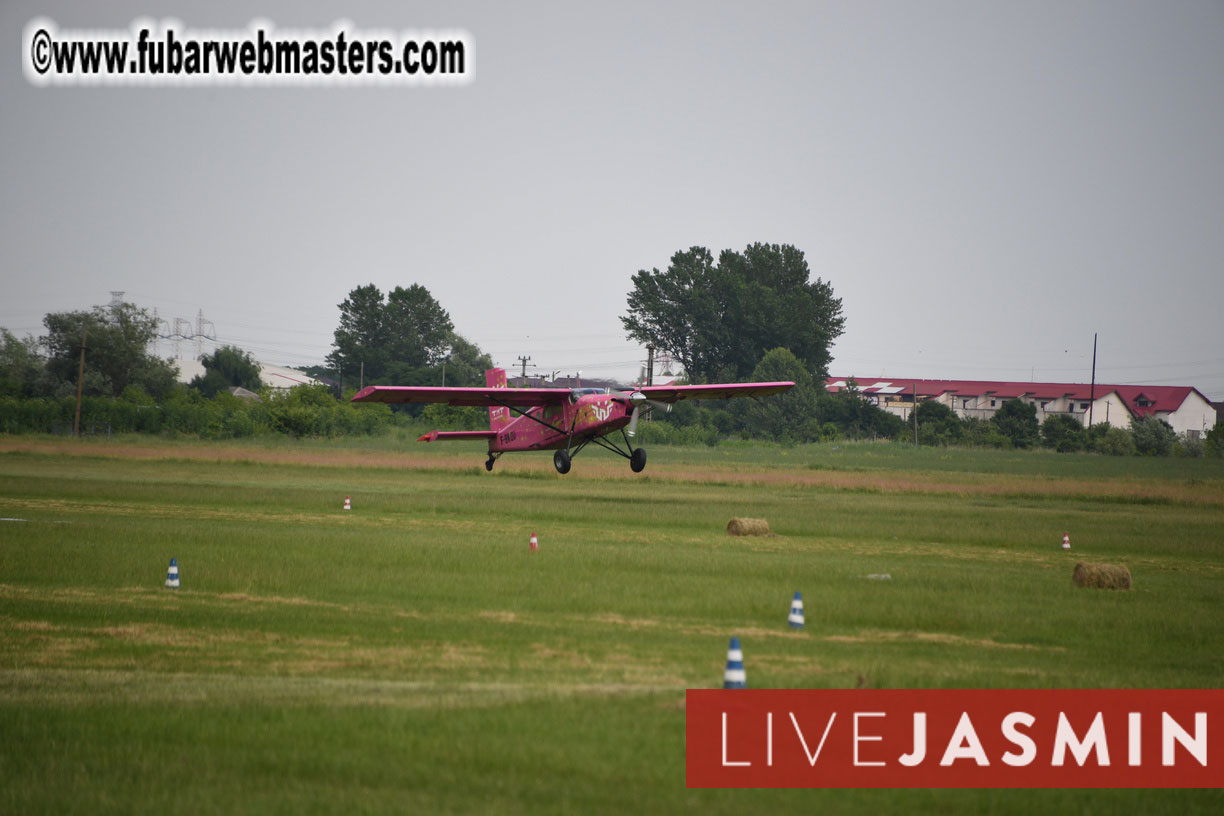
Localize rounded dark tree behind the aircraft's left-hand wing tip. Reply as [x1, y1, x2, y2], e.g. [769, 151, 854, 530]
[327, 284, 454, 385]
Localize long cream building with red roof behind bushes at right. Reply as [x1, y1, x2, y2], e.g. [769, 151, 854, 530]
[826, 377, 1215, 438]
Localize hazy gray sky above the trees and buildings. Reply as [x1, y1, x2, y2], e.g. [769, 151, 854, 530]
[0, 0, 1224, 399]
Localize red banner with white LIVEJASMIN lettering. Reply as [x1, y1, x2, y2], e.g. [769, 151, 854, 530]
[685, 689, 1224, 788]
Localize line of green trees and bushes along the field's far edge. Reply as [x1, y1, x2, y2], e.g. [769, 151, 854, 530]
[0, 243, 1224, 456]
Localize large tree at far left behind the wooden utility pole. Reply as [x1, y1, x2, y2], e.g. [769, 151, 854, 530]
[42, 303, 177, 398]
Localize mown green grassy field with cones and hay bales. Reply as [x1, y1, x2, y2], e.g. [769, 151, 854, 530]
[0, 433, 1224, 814]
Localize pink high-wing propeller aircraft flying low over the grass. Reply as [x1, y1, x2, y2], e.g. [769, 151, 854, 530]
[353, 368, 794, 473]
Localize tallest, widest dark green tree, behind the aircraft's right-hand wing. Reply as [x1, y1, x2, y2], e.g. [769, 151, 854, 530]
[621, 243, 845, 383]
